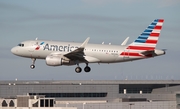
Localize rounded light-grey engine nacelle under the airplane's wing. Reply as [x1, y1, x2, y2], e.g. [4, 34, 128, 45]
[46, 55, 70, 66]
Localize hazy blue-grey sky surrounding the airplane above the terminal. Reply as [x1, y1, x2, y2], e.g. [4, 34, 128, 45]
[0, 0, 180, 80]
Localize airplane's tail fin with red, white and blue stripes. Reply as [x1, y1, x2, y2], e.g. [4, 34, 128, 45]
[127, 19, 164, 50]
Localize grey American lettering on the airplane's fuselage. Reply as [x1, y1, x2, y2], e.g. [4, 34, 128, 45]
[43, 43, 78, 52]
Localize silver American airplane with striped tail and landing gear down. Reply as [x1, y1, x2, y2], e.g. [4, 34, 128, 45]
[11, 19, 165, 73]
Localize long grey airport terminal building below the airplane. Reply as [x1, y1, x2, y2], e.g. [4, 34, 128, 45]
[0, 80, 180, 109]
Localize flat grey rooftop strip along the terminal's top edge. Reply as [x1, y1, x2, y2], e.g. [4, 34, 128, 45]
[0, 80, 180, 85]
